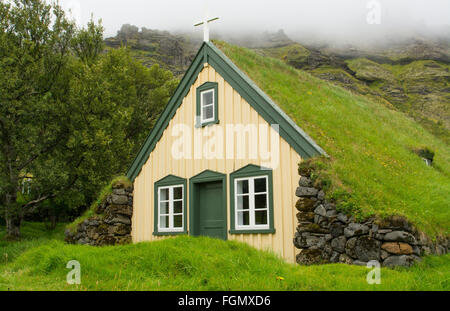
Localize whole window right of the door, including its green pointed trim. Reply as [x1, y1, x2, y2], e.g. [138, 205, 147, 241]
[230, 165, 275, 234]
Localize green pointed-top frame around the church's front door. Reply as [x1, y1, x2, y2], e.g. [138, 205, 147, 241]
[189, 170, 227, 236]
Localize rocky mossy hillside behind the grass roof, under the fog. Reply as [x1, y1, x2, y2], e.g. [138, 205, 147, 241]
[257, 42, 450, 144]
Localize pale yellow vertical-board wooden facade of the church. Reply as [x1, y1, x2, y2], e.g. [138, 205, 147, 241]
[132, 64, 301, 263]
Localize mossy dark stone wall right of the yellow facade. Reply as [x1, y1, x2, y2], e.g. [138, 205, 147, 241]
[294, 170, 450, 267]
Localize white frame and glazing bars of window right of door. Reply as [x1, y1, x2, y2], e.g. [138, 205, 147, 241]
[234, 176, 271, 230]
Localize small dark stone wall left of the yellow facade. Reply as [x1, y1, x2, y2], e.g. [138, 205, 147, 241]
[65, 183, 133, 246]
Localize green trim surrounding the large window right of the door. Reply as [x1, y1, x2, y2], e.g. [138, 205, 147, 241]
[229, 164, 275, 234]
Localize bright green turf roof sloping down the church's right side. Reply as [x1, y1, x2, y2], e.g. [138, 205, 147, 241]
[215, 42, 450, 236]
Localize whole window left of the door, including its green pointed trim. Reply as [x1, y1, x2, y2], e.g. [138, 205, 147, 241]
[153, 175, 187, 235]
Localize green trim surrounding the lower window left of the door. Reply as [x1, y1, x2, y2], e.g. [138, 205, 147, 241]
[153, 175, 188, 236]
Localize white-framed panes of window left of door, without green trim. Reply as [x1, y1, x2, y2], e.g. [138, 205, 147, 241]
[158, 185, 184, 232]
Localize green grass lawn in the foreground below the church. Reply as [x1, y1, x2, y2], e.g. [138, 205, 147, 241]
[0, 223, 450, 291]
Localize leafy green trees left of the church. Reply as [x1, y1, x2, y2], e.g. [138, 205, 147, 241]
[0, 0, 179, 238]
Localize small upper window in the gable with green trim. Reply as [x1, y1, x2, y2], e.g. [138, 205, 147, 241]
[196, 82, 219, 127]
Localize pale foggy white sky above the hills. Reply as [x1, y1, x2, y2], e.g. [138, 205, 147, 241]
[56, 0, 450, 41]
